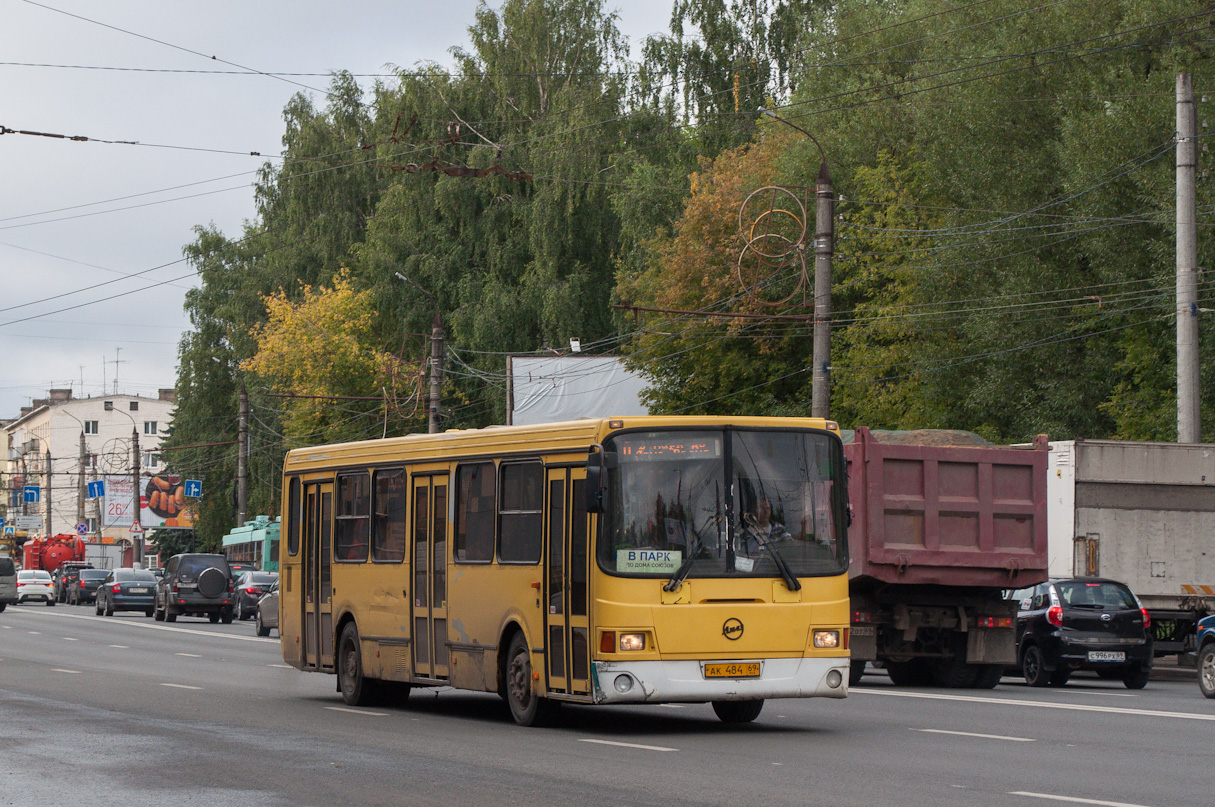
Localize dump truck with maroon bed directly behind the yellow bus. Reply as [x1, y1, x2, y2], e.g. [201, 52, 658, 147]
[844, 428, 1049, 688]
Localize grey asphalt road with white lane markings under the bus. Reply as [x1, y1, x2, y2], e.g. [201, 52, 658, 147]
[0, 605, 1215, 807]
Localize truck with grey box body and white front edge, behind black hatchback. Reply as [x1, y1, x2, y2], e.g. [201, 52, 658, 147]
[1047, 440, 1215, 658]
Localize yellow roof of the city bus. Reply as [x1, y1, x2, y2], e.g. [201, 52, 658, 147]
[283, 414, 840, 473]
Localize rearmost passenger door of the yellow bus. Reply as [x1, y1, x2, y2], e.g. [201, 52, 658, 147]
[301, 482, 333, 670]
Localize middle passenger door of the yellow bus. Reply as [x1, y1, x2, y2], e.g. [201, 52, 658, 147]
[413, 474, 450, 678]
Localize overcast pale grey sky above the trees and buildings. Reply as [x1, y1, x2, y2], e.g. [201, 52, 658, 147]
[0, 0, 671, 418]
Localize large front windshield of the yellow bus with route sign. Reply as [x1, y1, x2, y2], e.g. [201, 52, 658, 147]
[598, 429, 848, 577]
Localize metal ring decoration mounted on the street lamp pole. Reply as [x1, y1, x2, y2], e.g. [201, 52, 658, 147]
[735, 185, 809, 307]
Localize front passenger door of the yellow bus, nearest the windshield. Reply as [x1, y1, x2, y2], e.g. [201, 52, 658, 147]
[544, 468, 590, 695]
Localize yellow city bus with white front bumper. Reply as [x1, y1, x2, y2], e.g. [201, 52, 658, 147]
[279, 416, 849, 726]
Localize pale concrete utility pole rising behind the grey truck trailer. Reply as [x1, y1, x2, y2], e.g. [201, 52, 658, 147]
[1177, 73, 1200, 442]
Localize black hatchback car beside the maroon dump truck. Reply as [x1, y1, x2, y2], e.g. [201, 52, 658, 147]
[1012, 577, 1152, 689]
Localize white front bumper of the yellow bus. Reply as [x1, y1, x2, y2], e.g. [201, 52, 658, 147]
[590, 658, 848, 704]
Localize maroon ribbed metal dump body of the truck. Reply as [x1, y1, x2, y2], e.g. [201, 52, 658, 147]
[844, 428, 1047, 588]
